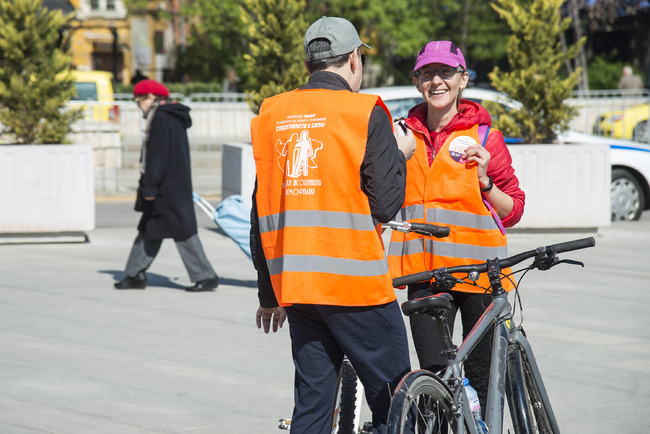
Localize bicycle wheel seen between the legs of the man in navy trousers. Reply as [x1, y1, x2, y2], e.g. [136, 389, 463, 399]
[331, 358, 360, 434]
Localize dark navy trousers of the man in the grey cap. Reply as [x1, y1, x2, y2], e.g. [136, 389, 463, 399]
[286, 301, 410, 434]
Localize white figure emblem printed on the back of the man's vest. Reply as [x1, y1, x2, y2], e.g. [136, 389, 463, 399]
[275, 130, 323, 178]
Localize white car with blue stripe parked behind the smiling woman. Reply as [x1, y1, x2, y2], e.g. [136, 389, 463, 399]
[361, 86, 650, 220]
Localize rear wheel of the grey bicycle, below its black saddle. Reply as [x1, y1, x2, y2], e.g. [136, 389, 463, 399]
[386, 370, 457, 434]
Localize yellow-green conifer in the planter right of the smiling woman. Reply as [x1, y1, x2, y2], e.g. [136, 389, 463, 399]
[486, 0, 585, 143]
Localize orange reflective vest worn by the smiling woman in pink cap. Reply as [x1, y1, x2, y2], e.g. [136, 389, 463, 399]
[388, 125, 513, 292]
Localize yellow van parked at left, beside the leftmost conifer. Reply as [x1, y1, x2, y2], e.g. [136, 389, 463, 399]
[71, 70, 119, 122]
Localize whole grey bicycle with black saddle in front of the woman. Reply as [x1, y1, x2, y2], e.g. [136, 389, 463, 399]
[387, 238, 595, 434]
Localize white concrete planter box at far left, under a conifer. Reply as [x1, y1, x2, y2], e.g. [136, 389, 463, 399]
[0, 145, 95, 239]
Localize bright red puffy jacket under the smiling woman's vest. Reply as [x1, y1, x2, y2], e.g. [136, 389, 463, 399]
[406, 100, 526, 228]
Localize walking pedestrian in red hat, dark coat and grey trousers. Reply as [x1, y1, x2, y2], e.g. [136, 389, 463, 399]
[115, 80, 219, 292]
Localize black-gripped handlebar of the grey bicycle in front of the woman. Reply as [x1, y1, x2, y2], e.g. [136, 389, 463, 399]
[393, 237, 596, 288]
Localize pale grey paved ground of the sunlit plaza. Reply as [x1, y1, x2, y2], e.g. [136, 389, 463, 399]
[0, 200, 650, 434]
